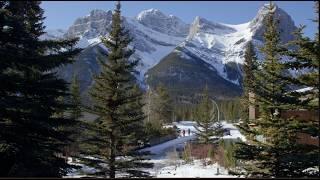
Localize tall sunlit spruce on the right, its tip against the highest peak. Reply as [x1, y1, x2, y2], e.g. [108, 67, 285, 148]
[236, 3, 304, 177]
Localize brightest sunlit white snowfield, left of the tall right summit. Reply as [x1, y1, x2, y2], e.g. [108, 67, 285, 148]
[180, 17, 252, 85]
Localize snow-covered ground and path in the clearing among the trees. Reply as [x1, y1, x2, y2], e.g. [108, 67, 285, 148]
[66, 121, 245, 178]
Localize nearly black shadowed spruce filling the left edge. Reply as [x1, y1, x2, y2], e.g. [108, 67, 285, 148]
[0, 1, 80, 177]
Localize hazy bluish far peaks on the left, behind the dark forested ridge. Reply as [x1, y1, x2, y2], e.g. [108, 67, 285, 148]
[59, 9, 188, 82]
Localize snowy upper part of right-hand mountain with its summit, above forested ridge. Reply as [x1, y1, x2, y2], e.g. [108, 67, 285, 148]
[172, 4, 296, 85]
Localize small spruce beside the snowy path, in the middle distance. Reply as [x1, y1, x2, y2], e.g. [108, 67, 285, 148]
[194, 86, 223, 144]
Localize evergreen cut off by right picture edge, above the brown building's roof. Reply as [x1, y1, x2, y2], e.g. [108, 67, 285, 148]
[281, 2, 320, 110]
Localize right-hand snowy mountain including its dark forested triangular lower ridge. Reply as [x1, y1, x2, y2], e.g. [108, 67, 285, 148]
[146, 5, 296, 99]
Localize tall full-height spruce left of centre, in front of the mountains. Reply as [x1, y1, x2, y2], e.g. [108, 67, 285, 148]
[86, 2, 150, 178]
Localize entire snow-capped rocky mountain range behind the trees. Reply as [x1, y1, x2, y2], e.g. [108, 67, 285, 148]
[47, 5, 296, 102]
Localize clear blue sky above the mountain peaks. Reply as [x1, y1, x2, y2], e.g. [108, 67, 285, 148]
[41, 1, 317, 37]
